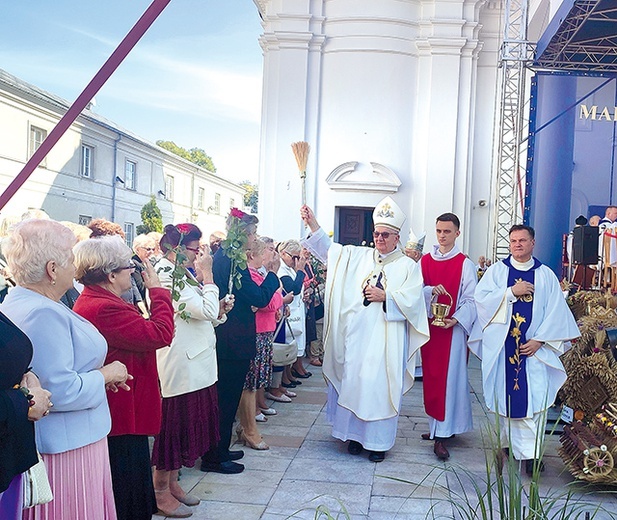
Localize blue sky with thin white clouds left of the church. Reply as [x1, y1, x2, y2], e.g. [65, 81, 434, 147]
[0, 0, 263, 182]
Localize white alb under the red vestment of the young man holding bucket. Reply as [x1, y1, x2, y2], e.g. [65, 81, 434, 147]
[424, 245, 478, 438]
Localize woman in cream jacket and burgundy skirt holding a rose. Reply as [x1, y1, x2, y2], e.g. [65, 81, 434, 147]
[152, 224, 233, 517]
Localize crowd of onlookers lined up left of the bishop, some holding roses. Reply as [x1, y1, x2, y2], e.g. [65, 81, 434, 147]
[0, 210, 325, 520]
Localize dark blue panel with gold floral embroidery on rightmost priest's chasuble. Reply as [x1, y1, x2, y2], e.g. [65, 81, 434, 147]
[503, 257, 542, 419]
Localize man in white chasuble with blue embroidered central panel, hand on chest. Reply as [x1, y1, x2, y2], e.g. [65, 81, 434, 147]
[469, 225, 580, 474]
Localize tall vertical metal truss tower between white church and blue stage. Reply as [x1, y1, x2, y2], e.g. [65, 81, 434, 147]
[493, 0, 535, 259]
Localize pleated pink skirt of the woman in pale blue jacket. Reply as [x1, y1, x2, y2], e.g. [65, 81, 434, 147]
[23, 438, 116, 520]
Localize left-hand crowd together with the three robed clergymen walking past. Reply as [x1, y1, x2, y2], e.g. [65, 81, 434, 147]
[0, 197, 578, 520]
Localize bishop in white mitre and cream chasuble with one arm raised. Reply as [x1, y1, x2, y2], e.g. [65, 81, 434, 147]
[301, 197, 429, 462]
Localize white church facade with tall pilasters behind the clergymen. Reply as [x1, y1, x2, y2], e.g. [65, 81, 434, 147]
[255, 0, 556, 258]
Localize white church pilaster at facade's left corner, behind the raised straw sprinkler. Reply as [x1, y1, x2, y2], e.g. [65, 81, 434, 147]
[257, 0, 325, 236]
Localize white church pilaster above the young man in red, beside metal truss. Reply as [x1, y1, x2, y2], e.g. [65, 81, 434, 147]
[413, 1, 481, 243]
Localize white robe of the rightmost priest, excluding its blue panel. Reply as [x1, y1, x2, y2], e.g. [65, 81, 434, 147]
[469, 258, 580, 459]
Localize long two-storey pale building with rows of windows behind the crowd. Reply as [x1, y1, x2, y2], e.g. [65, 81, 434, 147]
[0, 69, 244, 243]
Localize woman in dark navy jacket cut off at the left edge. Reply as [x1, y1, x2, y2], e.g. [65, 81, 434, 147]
[0, 314, 52, 520]
